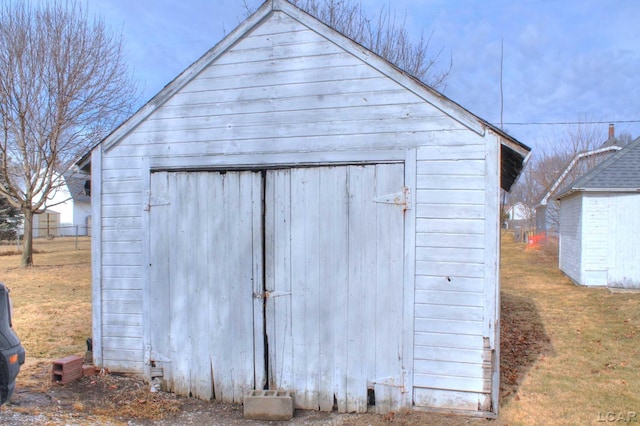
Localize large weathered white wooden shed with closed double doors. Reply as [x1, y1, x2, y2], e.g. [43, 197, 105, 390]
[83, 0, 529, 416]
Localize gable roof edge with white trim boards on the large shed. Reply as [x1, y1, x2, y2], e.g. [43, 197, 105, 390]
[79, 0, 530, 190]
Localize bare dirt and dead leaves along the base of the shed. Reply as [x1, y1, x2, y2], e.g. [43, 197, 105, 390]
[0, 286, 551, 426]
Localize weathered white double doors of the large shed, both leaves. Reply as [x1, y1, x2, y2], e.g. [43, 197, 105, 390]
[145, 164, 405, 412]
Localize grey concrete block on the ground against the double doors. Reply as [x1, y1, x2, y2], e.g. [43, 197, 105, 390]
[244, 390, 294, 420]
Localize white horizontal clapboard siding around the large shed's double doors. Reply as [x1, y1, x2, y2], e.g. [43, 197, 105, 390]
[94, 4, 516, 411]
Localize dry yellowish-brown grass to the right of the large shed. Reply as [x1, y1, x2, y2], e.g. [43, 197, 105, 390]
[500, 235, 640, 424]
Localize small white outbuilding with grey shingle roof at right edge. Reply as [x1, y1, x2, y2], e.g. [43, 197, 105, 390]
[556, 138, 640, 288]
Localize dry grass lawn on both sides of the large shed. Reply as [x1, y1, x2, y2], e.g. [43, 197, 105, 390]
[0, 235, 640, 425]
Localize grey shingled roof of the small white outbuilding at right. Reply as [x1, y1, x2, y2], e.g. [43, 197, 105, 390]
[558, 138, 640, 198]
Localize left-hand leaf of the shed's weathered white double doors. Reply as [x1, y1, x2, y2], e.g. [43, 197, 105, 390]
[145, 172, 264, 403]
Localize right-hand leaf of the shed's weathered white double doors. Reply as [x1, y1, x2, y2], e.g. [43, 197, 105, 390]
[265, 164, 404, 413]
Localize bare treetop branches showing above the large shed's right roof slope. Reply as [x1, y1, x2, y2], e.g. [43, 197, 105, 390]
[244, 0, 453, 90]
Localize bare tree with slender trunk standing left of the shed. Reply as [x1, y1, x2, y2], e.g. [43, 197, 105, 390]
[0, 0, 137, 267]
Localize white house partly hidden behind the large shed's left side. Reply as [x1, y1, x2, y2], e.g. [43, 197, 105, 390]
[33, 171, 91, 237]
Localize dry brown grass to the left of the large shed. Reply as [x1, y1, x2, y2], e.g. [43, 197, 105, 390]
[0, 237, 91, 362]
